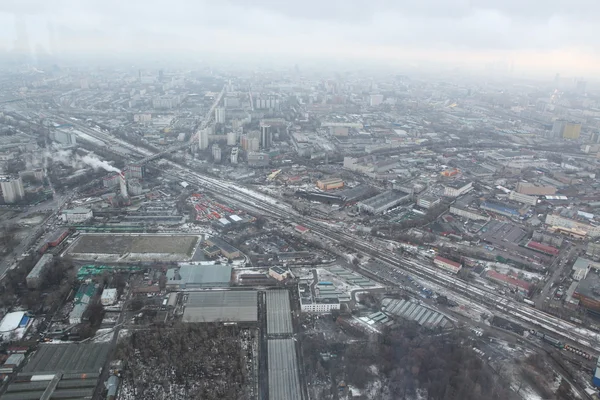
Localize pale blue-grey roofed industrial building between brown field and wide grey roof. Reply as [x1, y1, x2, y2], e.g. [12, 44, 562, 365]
[167, 264, 232, 290]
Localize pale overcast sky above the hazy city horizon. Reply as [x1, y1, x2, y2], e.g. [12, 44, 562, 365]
[0, 0, 600, 78]
